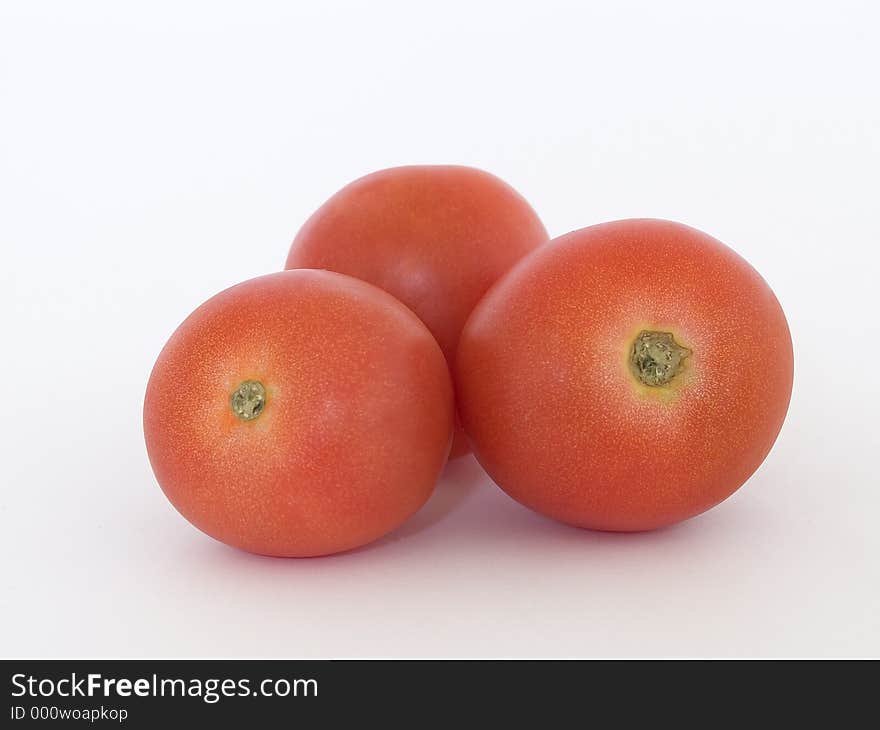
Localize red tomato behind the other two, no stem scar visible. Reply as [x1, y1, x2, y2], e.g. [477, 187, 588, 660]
[286, 165, 547, 457]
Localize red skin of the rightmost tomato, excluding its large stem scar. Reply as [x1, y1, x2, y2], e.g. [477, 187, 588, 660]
[456, 220, 793, 531]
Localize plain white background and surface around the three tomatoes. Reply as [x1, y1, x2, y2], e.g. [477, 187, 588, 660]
[0, 0, 880, 657]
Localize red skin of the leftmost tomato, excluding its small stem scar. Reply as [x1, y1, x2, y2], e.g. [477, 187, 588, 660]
[144, 270, 454, 557]
